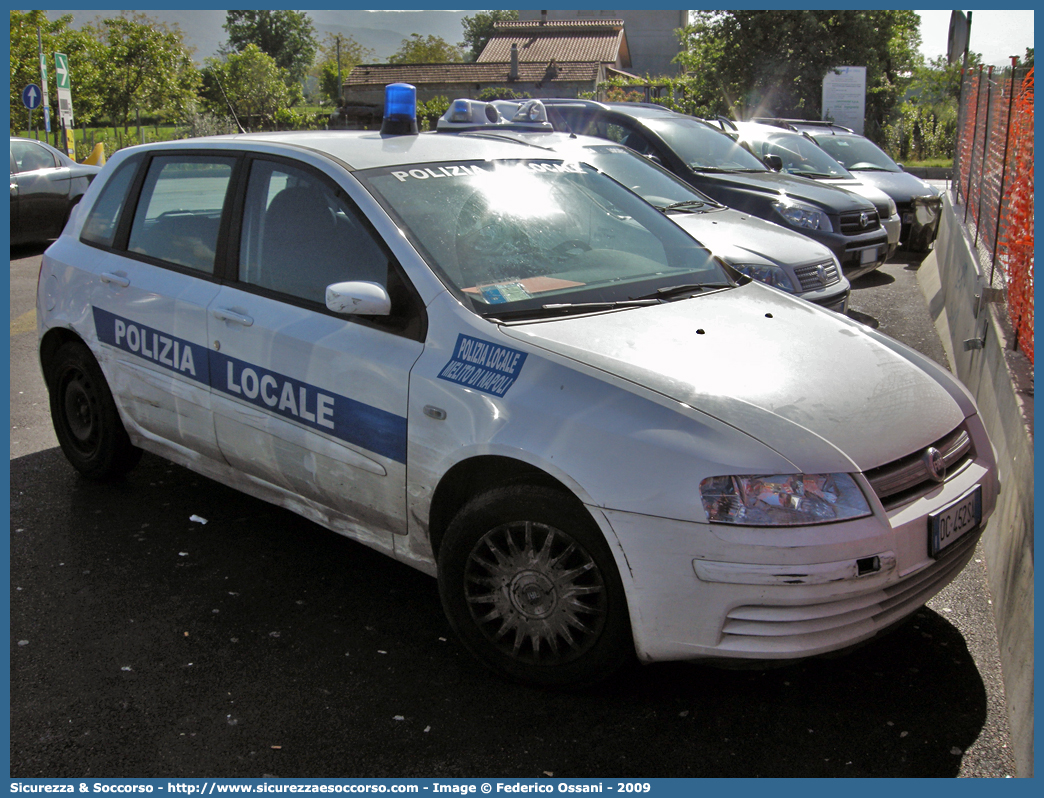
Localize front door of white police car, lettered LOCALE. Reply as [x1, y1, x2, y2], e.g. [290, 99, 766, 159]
[207, 152, 424, 548]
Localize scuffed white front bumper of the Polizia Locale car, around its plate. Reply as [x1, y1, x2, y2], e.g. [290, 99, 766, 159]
[601, 444, 997, 661]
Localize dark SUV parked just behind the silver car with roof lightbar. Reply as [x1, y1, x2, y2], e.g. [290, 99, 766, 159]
[542, 99, 888, 280]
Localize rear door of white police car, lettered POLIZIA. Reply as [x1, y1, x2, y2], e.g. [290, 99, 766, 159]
[81, 151, 238, 459]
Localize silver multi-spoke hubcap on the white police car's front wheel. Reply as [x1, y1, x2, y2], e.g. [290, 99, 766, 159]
[465, 521, 607, 665]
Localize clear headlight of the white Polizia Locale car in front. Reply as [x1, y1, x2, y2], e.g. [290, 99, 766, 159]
[699, 474, 871, 526]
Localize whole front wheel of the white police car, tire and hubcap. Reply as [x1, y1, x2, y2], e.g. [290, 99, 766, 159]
[438, 486, 635, 687]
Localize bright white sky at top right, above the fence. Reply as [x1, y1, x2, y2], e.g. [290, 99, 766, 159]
[918, 9, 1034, 67]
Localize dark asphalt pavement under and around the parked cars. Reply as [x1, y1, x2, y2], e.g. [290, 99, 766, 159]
[10, 240, 1015, 779]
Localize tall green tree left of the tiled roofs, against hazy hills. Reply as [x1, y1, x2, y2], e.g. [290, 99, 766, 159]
[222, 10, 316, 85]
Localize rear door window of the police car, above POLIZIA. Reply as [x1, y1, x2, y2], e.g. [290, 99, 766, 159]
[127, 156, 235, 274]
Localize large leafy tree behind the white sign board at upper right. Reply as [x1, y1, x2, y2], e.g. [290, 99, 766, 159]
[677, 10, 921, 137]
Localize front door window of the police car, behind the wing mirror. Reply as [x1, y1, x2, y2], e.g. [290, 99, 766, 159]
[239, 160, 389, 304]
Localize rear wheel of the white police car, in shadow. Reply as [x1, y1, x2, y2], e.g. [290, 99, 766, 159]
[47, 342, 142, 482]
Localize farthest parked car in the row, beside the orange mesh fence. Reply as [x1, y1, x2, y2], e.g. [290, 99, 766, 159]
[755, 119, 943, 252]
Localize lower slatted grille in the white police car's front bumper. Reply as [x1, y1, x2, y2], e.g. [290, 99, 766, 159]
[719, 532, 980, 656]
